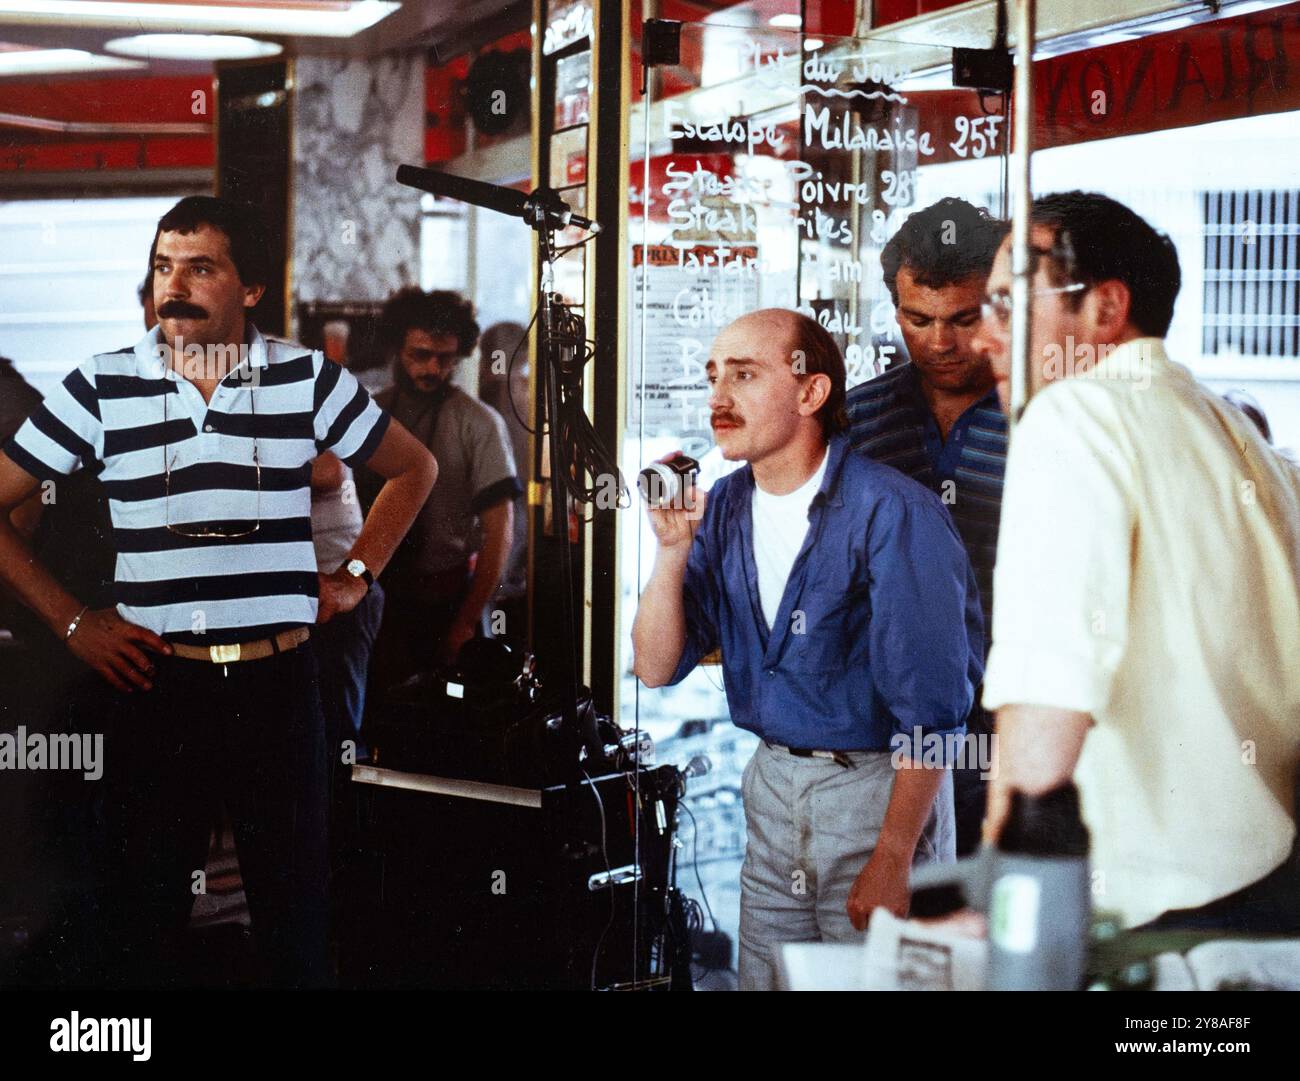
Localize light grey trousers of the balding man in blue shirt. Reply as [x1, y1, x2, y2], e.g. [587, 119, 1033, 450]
[740, 743, 957, 991]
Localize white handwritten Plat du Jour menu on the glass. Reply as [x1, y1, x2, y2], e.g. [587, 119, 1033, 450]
[625, 25, 1006, 453]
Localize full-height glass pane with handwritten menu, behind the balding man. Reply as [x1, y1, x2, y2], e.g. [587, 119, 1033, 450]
[619, 14, 1008, 986]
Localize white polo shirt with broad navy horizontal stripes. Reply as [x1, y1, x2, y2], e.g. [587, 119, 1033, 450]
[5, 325, 389, 646]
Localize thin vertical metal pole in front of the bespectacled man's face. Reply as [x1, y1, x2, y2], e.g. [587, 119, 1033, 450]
[1009, 0, 1037, 427]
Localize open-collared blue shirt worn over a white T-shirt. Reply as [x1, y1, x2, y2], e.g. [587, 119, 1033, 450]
[670, 434, 984, 751]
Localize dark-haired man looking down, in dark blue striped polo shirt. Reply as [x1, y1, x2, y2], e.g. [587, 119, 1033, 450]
[846, 197, 1006, 855]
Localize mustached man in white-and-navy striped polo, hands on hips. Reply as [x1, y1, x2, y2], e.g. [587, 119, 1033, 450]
[0, 196, 437, 986]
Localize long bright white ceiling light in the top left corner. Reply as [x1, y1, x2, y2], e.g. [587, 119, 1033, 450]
[0, 0, 402, 38]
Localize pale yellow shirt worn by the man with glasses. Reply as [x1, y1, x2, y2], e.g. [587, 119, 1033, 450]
[984, 338, 1300, 926]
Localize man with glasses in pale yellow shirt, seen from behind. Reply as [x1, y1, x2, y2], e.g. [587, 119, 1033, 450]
[976, 191, 1300, 934]
